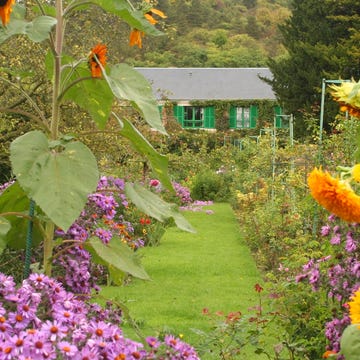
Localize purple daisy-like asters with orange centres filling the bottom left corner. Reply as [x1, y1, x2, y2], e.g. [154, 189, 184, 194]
[0, 273, 199, 360]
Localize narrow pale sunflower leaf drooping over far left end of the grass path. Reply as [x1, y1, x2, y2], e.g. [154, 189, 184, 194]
[125, 183, 195, 233]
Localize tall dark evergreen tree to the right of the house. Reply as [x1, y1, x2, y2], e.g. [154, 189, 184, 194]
[268, 0, 360, 136]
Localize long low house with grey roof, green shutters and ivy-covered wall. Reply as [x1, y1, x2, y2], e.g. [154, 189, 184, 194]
[136, 68, 283, 129]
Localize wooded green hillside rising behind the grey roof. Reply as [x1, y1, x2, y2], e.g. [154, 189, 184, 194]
[123, 0, 290, 67]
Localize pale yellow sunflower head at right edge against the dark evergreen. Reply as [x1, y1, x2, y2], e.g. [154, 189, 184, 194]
[329, 80, 360, 118]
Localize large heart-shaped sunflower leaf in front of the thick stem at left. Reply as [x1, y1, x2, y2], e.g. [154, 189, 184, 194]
[10, 131, 99, 231]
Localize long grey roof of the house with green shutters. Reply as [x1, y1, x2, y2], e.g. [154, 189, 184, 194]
[136, 68, 276, 101]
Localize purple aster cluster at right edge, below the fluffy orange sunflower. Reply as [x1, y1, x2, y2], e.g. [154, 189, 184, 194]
[296, 216, 360, 352]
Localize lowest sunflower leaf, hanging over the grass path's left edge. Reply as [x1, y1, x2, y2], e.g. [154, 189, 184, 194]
[84, 237, 149, 282]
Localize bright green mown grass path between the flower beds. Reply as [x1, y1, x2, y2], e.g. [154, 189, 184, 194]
[102, 204, 261, 358]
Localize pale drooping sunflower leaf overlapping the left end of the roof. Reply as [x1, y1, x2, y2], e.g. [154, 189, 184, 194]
[103, 64, 166, 134]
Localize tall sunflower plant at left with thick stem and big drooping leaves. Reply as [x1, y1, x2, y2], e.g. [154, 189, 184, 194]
[0, 0, 192, 283]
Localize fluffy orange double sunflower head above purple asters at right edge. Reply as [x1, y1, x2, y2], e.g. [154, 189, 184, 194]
[308, 168, 360, 223]
